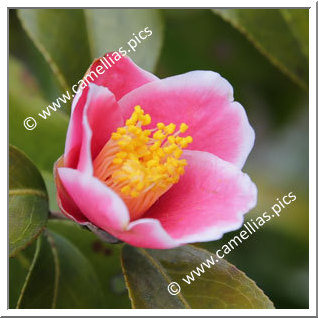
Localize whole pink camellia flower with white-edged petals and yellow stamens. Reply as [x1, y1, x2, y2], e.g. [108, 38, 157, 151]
[54, 53, 257, 249]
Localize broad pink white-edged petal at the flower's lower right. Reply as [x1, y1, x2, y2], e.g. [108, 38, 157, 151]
[145, 150, 257, 244]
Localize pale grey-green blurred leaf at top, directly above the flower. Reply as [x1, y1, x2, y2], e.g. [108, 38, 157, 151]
[84, 9, 163, 71]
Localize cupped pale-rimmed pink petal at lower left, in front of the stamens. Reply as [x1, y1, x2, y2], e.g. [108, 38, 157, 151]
[58, 168, 129, 234]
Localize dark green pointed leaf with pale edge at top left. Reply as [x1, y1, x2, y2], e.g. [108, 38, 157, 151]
[18, 9, 91, 90]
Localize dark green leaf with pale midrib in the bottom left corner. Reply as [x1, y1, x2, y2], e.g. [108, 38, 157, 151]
[16, 231, 103, 309]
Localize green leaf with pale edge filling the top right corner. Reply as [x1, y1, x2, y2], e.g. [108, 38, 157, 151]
[213, 9, 309, 88]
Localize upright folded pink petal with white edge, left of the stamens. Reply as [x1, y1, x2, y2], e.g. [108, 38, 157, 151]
[64, 84, 123, 174]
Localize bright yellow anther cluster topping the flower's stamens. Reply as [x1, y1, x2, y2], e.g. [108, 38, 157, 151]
[111, 106, 192, 197]
